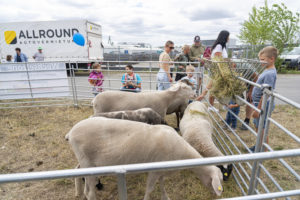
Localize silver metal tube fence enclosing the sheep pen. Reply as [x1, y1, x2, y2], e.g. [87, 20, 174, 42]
[0, 58, 300, 199]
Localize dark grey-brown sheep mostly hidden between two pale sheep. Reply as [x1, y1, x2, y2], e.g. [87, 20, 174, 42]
[92, 108, 166, 124]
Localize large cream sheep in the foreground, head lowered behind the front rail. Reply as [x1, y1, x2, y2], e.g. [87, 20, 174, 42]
[66, 117, 223, 200]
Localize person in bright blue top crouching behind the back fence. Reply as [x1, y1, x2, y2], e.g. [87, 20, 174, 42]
[121, 65, 142, 92]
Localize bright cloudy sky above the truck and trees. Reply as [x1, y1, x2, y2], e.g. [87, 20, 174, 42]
[0, 0, 300, 46]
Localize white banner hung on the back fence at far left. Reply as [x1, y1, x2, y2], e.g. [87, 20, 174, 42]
[0, 62, 70, 100]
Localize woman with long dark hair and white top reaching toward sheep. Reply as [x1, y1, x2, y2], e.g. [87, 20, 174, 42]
[197, 30, 230, 105]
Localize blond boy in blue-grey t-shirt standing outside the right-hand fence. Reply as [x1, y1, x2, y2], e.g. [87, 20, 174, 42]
[250, 46, 278, 152]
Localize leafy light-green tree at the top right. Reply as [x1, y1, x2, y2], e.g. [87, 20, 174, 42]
[239, 0, 300, 67]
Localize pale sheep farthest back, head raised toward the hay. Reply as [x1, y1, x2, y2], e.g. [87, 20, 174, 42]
[92, 82, 194, 119]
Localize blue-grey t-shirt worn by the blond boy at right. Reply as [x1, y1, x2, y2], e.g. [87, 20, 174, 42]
[252, 68, 277, 103]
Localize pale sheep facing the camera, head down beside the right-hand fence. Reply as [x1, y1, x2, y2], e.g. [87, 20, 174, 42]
[180, 101, 232, 181]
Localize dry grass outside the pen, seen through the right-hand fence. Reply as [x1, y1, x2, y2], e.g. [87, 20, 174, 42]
[212, 105, 300, 199]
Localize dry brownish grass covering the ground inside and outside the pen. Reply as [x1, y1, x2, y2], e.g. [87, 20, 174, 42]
[0, 106, 300, 200]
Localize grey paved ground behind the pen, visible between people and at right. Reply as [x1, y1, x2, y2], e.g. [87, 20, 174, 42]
[71, 72, 300, 104]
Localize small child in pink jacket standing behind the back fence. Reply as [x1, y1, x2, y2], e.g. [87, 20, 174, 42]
[88, 63, 104, 96]
